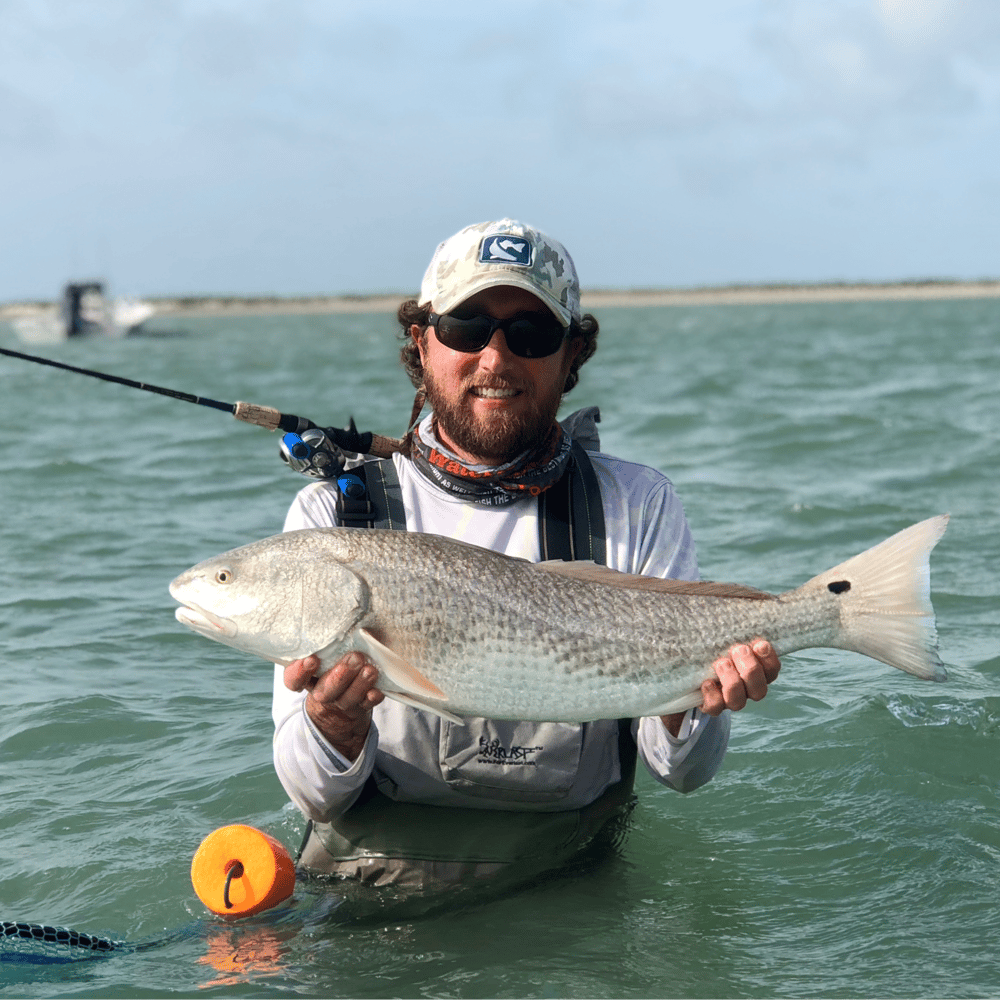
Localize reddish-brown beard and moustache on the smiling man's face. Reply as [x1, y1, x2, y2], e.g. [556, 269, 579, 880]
[424, 368, 563, 465]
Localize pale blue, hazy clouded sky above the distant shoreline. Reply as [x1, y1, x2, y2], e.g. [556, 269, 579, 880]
[0, 0, 1000, 302]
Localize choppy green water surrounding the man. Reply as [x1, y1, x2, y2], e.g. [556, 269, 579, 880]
[0, 300, 1000, 1000]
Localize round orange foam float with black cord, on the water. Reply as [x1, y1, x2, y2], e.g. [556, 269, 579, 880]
[191, 823, 295, 917]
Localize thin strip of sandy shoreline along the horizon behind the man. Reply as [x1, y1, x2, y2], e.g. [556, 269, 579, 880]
[0, 280, 1000, 320]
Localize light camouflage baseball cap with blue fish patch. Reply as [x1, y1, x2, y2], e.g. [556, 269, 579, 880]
[420, 219, 580, 326]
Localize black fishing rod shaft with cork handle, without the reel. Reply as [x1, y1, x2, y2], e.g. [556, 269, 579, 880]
[0, 347, 401, 458]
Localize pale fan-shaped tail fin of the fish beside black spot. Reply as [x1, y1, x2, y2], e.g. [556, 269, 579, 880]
[803, 514, 948, 681]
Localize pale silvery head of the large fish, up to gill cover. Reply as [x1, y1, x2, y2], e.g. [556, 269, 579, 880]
[170, 532, 368, 664]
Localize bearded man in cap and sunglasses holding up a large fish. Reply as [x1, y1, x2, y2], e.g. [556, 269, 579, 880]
[273, 219, 780, 888]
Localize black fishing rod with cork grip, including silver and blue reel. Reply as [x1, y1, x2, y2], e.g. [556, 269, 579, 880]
[0, 347, 403, 479]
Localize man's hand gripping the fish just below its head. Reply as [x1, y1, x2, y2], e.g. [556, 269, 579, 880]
[284, 652, 385, 761]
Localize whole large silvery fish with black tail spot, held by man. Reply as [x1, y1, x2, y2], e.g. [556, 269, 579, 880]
[171, 515, 948, 722]
